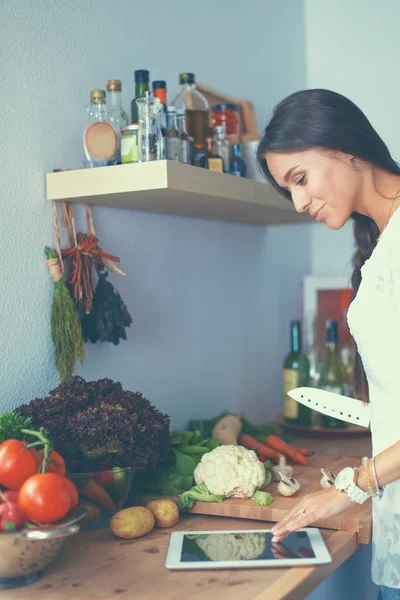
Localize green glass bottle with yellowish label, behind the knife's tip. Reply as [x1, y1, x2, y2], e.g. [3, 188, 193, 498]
[283, 321, 312, 427]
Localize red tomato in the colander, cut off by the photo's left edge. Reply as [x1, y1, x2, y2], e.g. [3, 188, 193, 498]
[0, 440, 38, 490]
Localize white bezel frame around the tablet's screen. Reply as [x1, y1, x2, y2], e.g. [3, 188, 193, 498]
[165, 527, 332, 570]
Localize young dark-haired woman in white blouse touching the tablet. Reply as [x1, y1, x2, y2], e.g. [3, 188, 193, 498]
[258, 90, 400, 600]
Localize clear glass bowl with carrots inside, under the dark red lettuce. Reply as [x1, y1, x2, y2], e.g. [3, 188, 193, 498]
[67, 467, 133, 529]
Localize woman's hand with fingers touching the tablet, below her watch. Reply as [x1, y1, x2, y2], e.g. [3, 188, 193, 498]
[271, 488, 354, 543]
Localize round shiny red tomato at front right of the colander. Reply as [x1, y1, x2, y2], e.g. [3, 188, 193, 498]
[18, 473, 71, 524]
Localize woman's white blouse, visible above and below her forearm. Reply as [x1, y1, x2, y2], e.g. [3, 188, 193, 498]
[347, 208, 400, 588]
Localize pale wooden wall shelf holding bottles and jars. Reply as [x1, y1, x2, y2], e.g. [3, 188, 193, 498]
[46, 160, 308, 225]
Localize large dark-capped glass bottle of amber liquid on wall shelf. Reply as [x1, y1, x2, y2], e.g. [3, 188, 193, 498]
[172, 73, 210, 154]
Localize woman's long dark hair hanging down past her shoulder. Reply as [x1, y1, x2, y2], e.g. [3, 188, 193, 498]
[257, 89, 400, 401]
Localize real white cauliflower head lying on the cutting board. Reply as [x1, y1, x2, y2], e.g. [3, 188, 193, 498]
[194, 445, 265, 498]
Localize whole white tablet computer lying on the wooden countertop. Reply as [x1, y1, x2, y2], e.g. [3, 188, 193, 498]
[165, 527, 332, 569]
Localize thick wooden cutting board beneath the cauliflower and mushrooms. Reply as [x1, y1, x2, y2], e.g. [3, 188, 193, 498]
[135, 455, 372, 544]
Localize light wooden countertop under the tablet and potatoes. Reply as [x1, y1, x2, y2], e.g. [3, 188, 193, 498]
[1, 438, 370, 600]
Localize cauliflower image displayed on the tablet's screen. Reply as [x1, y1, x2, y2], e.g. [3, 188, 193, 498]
[196, 533, 267, 561]
